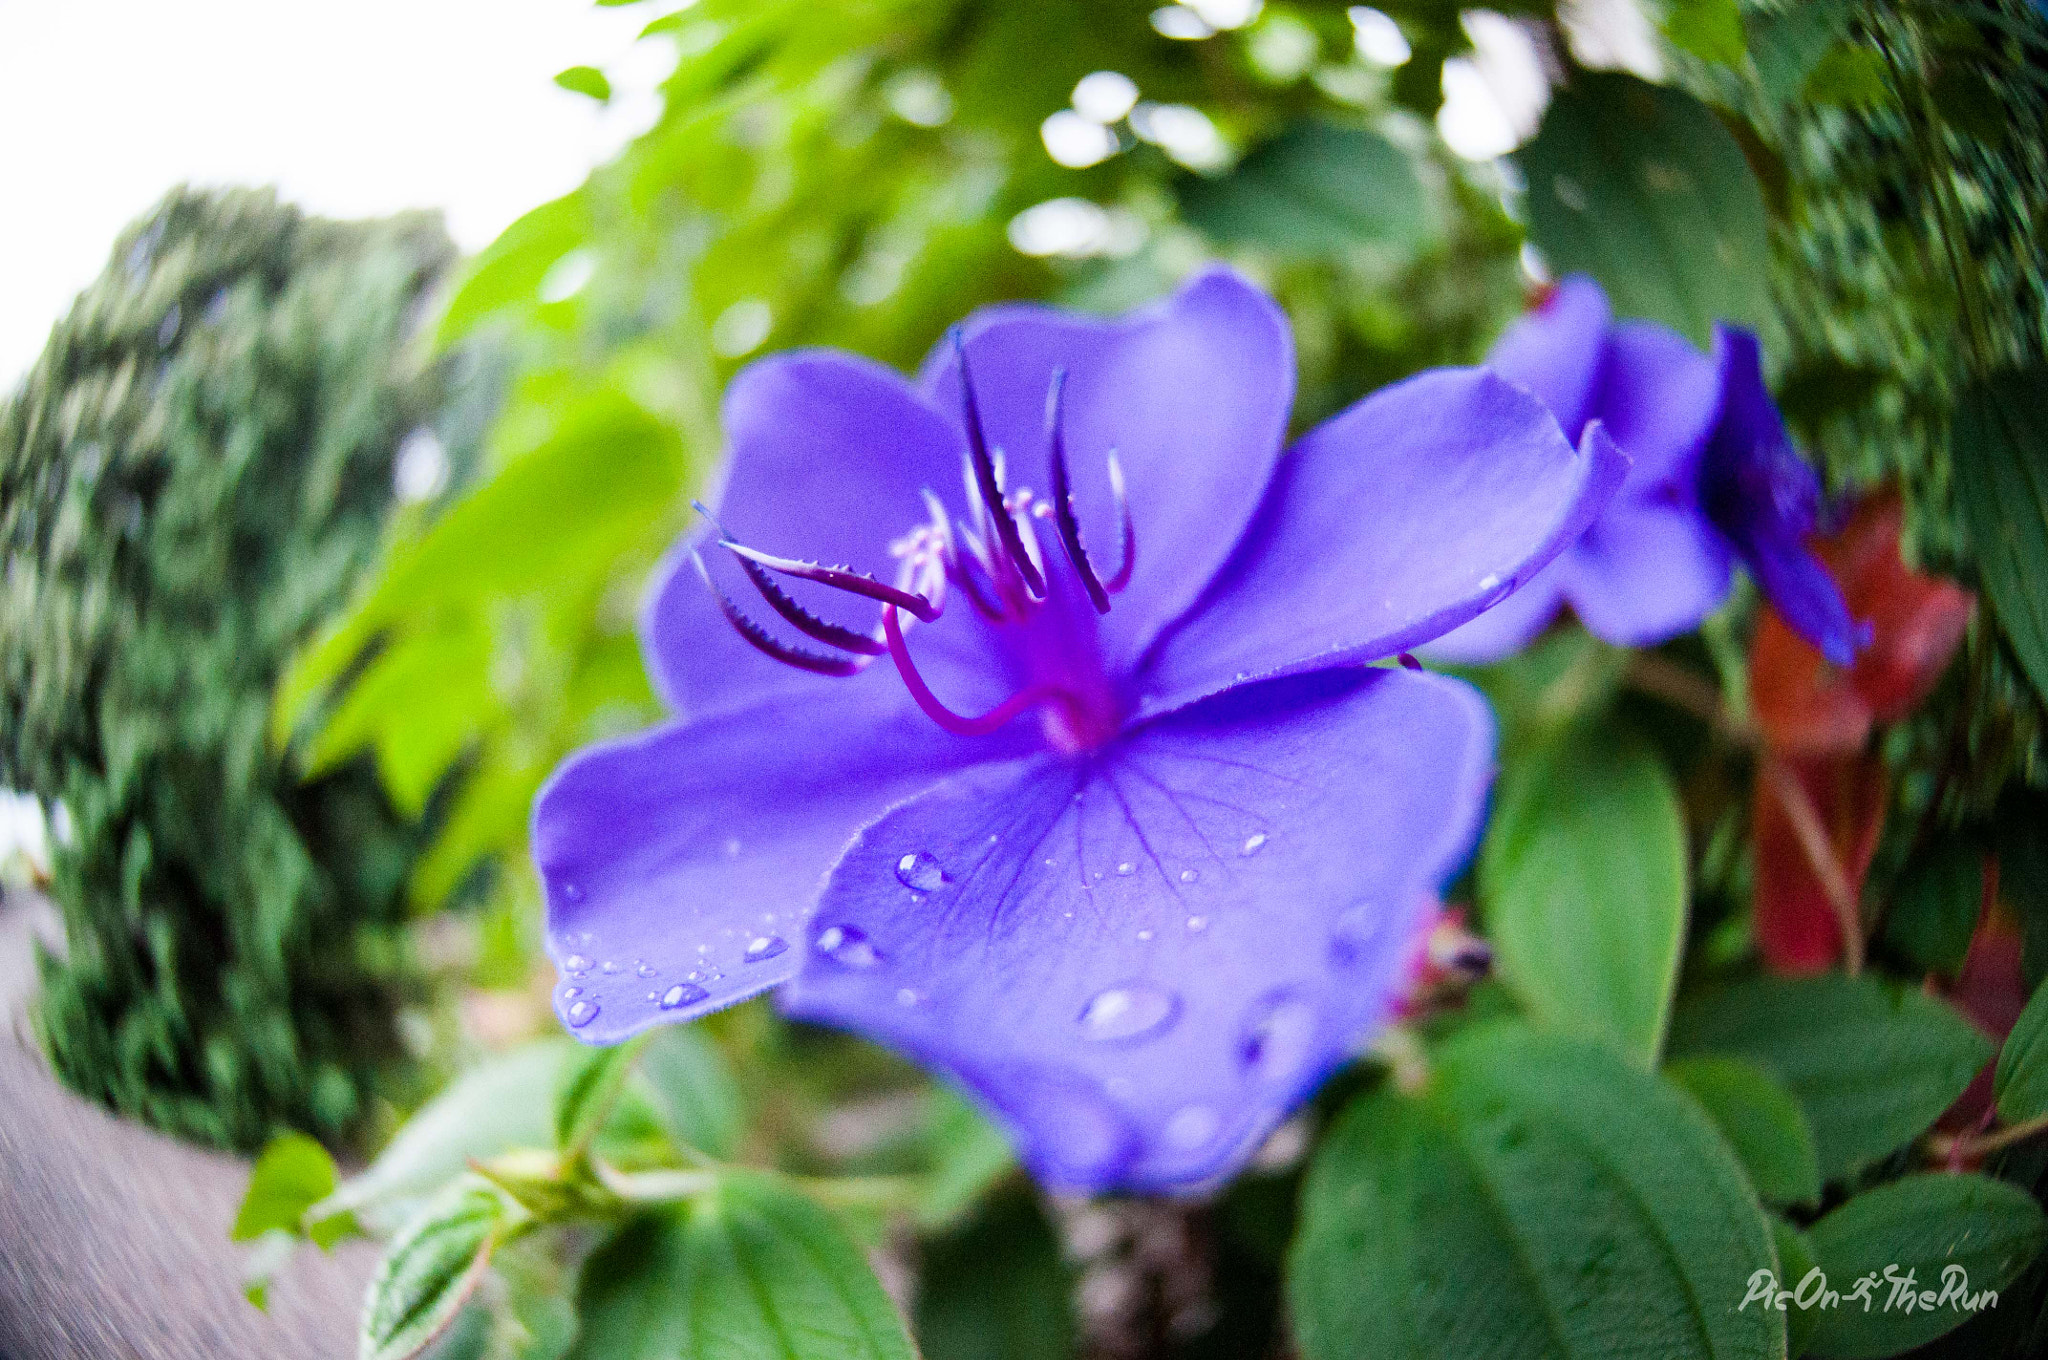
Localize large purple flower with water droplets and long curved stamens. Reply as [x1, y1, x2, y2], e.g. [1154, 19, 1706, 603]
[532, 270, 1624, 1188]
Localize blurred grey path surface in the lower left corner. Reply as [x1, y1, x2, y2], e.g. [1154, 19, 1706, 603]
[0, 893, 375, 1360]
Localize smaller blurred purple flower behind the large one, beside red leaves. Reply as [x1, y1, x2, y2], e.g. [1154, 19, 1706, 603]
[1430, 277, 1853, 664]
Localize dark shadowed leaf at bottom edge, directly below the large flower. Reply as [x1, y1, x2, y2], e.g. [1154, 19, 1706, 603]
[918, 1194, 1073, 1360]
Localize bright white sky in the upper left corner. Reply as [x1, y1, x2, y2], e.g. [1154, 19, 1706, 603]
[0, 0, 659, 389]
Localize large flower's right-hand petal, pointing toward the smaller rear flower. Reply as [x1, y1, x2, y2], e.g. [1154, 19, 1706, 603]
[1141, 369, 1628, 713]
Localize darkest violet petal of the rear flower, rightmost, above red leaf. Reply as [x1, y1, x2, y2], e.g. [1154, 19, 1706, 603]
[1700, 326, 1858, 666]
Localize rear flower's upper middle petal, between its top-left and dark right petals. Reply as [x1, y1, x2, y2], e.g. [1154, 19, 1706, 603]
[1589, 322, 1720, 496]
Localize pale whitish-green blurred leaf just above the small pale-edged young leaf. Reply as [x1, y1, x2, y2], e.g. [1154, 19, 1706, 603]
[319, 1038, 582, 1229]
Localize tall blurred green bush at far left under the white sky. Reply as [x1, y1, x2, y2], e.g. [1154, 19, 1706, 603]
[0, 190, 475, 1147]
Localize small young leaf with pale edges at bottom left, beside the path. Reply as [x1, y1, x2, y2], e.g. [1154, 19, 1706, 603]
[356, 1182, 506, 1360]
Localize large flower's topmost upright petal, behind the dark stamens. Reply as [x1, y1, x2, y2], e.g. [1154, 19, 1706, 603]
[920, 268, 1294, 674]
